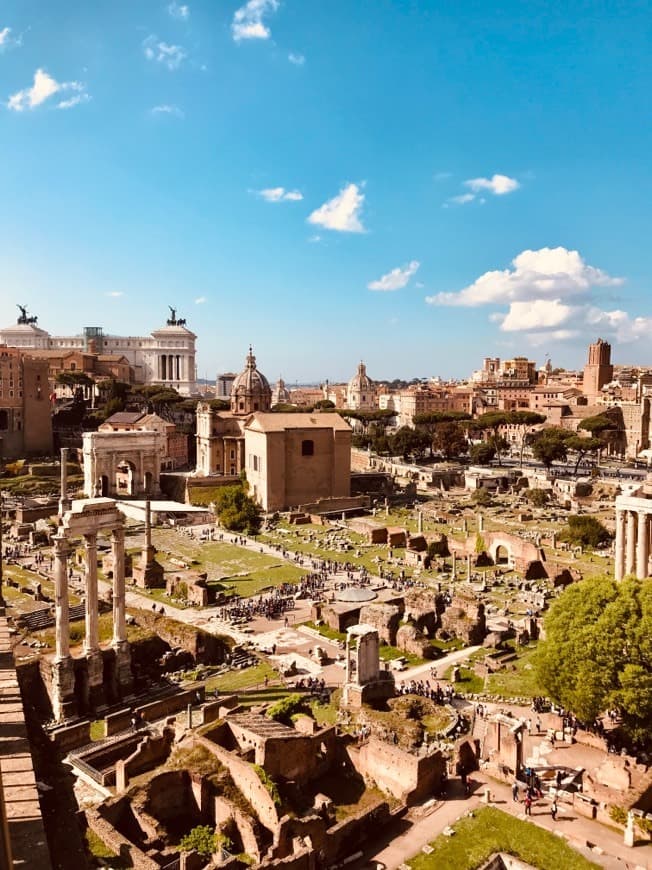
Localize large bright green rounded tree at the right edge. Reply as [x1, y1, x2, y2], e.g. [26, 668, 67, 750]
[536, 577, 652, 747]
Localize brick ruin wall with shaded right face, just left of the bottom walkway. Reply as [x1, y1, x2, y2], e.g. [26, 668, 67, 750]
[351, 737, 446, 805]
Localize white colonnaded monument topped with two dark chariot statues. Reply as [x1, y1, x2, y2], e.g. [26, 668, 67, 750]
[0, 306, 197, 396]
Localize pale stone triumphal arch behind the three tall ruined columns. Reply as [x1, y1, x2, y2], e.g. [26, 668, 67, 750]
[83, 430, 164, 499]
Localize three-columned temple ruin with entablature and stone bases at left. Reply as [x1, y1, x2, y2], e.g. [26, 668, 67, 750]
[45, 498, 132, 721]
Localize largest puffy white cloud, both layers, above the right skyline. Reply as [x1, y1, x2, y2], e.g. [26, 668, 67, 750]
[426, 247, 652, 346]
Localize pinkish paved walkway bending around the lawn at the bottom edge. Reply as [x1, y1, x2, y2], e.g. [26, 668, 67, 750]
[365, 772, 652, 870]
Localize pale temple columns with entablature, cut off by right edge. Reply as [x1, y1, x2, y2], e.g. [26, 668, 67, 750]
[615, 475, 652, 580]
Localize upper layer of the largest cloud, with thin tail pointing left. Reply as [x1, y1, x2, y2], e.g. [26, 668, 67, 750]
[426, 247, 623, 306]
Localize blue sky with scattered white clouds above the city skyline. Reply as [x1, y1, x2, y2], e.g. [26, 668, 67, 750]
[0, 0, 652, 382]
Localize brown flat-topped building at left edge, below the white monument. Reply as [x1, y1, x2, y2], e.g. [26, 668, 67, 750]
[0, 345, 52, 458]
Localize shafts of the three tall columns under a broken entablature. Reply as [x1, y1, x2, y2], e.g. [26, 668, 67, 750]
[53, 528, 127, 662]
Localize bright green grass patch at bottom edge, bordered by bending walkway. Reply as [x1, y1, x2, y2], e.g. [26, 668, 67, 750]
[408, 807, 599, 870]
